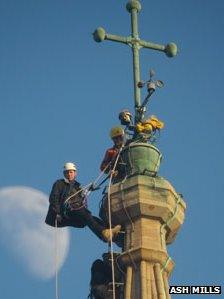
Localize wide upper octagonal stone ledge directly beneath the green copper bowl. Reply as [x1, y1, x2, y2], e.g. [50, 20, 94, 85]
[106, 175, 186, 243]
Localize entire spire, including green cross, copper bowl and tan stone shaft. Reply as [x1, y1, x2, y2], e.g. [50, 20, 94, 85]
[94, 0, 186, 299]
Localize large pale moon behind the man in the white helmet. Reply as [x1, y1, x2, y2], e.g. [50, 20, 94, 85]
[0, 186, 70, 280]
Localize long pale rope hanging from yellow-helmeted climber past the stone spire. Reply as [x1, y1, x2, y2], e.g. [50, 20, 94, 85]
[107, 147, 123, 299]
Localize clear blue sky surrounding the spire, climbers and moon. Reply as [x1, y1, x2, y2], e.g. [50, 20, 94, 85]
[0, 0, 224, 299]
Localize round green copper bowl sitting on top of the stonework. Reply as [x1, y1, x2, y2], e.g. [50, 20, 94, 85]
[121, 143, 162, 176]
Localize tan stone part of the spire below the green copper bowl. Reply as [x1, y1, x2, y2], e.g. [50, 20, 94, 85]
[111, 175, 186, 299]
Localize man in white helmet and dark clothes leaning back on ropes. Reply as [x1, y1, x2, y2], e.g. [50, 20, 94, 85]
[45, 162, 121, 242]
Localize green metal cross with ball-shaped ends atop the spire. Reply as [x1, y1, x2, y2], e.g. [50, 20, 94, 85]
[93, 0, 177, 122]
